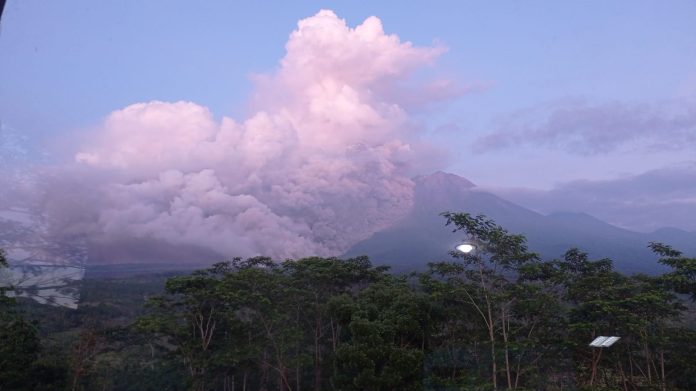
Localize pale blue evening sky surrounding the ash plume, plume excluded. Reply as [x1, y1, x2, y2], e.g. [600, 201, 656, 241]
[0, 0, 696, 233]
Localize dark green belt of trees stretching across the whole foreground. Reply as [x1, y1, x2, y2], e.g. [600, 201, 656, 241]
[0, 213, 696, 391]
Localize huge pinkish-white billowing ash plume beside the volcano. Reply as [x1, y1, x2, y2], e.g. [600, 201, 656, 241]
[38, 11, 448, 261]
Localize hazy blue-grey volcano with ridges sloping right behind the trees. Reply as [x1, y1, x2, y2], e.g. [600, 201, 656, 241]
[345, 172, 696, 273]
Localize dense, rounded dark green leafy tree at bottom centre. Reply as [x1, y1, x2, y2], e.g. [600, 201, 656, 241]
[334, 278, 433, 390]
